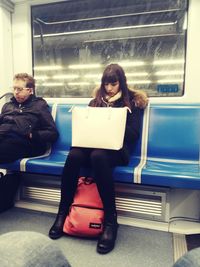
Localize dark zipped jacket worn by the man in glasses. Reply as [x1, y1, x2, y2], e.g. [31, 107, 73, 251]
[0, 95, 58, 144]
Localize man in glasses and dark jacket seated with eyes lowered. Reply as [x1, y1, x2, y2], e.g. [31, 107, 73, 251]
[0, 73, 58, 163]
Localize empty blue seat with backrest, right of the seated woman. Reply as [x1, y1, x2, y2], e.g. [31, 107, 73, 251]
[141, 105, 200, 189]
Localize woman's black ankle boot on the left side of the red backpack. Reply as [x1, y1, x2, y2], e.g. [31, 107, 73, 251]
[49, 212, 67, 239]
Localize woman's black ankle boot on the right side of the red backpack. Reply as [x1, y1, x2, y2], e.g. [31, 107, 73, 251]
[97, 222, 118, 254]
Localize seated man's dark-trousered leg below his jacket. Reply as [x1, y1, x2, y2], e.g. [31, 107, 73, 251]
[0, 137, 31, 163]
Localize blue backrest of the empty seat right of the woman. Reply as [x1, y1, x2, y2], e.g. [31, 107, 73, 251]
[147, 105, 200, 161]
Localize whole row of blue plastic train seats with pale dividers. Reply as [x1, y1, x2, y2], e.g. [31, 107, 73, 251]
[0, 101, 200, 192]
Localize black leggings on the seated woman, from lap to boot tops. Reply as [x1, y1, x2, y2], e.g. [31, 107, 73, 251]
[59, 147, 124, 219]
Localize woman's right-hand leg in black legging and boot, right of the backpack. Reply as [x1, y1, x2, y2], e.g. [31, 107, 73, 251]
[90, 149, 123, 254]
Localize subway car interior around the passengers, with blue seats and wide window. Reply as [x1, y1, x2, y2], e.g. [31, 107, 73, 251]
[0, 0, 200, 267]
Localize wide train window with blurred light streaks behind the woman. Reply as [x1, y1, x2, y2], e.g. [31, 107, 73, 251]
[31, 0, 188, 97]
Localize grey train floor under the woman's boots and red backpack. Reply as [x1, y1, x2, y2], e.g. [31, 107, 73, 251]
[0, 208, 200, 267]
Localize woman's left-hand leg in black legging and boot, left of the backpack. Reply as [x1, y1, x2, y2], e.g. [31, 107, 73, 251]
[49, 148, 89, 239]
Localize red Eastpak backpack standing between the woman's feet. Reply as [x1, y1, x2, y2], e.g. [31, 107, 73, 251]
[63, 177, 104, 237]
